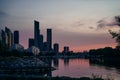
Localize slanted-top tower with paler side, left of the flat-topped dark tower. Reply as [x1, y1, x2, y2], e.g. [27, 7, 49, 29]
[5, 27, 13, 48]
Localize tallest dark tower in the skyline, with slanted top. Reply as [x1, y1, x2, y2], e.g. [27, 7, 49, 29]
[34, 20, 40, 48]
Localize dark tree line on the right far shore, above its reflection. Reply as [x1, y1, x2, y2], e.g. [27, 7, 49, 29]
[89, 47, 120, 58]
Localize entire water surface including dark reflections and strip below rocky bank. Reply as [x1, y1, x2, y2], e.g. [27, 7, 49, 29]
[0, 58, 120, 80]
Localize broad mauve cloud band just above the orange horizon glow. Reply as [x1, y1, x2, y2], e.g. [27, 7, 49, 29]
[53, 30, 112, 48]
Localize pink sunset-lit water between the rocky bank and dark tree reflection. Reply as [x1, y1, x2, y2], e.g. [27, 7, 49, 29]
[52, 59, 120, 80]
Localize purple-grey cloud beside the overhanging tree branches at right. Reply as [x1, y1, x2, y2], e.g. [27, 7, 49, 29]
[97, 18, 120, 29]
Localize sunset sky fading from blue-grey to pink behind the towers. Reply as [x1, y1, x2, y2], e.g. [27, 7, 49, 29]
[0, 0, 120, 52]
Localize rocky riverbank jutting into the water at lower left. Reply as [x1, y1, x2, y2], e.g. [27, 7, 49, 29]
[0, 57, 55, 76]
